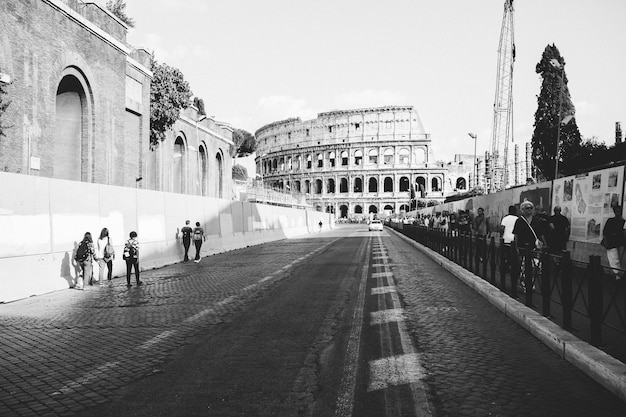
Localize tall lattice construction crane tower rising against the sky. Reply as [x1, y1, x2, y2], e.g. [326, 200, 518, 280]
[488, 0, 515, 192]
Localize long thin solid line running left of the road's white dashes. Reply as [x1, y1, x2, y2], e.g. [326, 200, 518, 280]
[335, 239, 370, 417]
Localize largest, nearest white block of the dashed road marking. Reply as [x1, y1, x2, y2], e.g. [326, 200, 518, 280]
[367, 353, 426, 392]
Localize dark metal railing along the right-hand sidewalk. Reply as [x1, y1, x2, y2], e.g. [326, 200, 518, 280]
[388, 223, 626, 363]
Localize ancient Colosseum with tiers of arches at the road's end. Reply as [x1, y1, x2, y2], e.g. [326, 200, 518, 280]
[255, 106, 447, 218]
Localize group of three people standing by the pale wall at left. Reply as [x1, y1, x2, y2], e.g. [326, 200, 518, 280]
[74, 227, 142, 290]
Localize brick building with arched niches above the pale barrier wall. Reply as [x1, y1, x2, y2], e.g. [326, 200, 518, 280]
[0, 0, 232, 198]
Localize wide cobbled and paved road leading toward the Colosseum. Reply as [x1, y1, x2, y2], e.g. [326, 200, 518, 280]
[0, 226, 626, 417]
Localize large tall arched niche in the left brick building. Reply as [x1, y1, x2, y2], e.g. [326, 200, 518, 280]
[52, 67, 93, 181]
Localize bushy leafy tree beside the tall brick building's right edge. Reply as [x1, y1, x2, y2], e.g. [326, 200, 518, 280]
[150, 59, 192, 149]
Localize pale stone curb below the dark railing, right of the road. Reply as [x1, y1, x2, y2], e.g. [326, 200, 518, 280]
[391, 229, 626, 402]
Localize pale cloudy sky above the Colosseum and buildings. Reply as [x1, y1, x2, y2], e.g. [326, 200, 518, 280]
[119, 0, 626, 166]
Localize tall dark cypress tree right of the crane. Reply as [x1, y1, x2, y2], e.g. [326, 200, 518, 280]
[532, 44, 582, 180]
